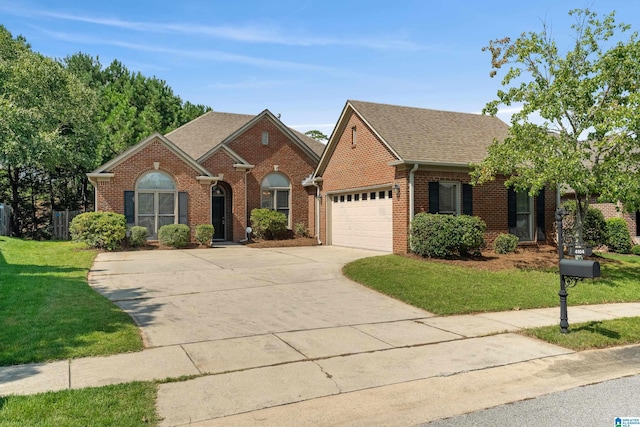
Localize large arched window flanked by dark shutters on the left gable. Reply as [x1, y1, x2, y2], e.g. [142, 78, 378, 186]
[135, 171, 178, 240]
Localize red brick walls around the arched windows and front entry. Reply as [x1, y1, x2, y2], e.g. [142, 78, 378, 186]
[96, 118, 316, 241]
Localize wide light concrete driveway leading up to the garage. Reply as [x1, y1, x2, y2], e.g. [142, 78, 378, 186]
[89, 246, 431, 347]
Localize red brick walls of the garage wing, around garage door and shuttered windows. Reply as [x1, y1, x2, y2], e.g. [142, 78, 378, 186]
[320, 110, 555, 253]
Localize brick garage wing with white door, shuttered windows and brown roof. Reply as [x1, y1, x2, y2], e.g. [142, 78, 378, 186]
[304, 101, 555, 253]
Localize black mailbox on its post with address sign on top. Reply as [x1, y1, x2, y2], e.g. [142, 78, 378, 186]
[556, 208, 600, 334]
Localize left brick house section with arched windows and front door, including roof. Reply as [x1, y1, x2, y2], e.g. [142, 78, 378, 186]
[88, 110, 324, 241]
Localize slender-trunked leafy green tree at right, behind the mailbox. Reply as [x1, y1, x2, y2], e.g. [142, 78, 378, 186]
[472, 9, 640, 247]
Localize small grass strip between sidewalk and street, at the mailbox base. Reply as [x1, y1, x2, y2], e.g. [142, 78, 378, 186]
[521, 314, 640, 351]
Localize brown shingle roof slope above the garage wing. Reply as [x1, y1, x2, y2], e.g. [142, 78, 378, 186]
[349, 101, 509, 164]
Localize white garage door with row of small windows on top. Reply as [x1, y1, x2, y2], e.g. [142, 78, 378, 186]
[330, 189, 393, 252]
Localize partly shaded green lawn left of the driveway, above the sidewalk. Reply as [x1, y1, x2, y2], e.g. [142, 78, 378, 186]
[0, 237, 142, 366]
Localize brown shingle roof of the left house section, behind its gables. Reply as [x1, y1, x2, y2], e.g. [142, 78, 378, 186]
[165, 111, 324, 160]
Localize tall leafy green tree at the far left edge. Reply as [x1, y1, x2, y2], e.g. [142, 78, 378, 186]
[0, 27, 98, 235]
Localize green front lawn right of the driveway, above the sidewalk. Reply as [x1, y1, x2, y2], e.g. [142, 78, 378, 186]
[343, 254, 640, 315]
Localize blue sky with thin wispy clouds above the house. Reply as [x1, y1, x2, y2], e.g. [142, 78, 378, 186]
[0, 0, 640, 135]
